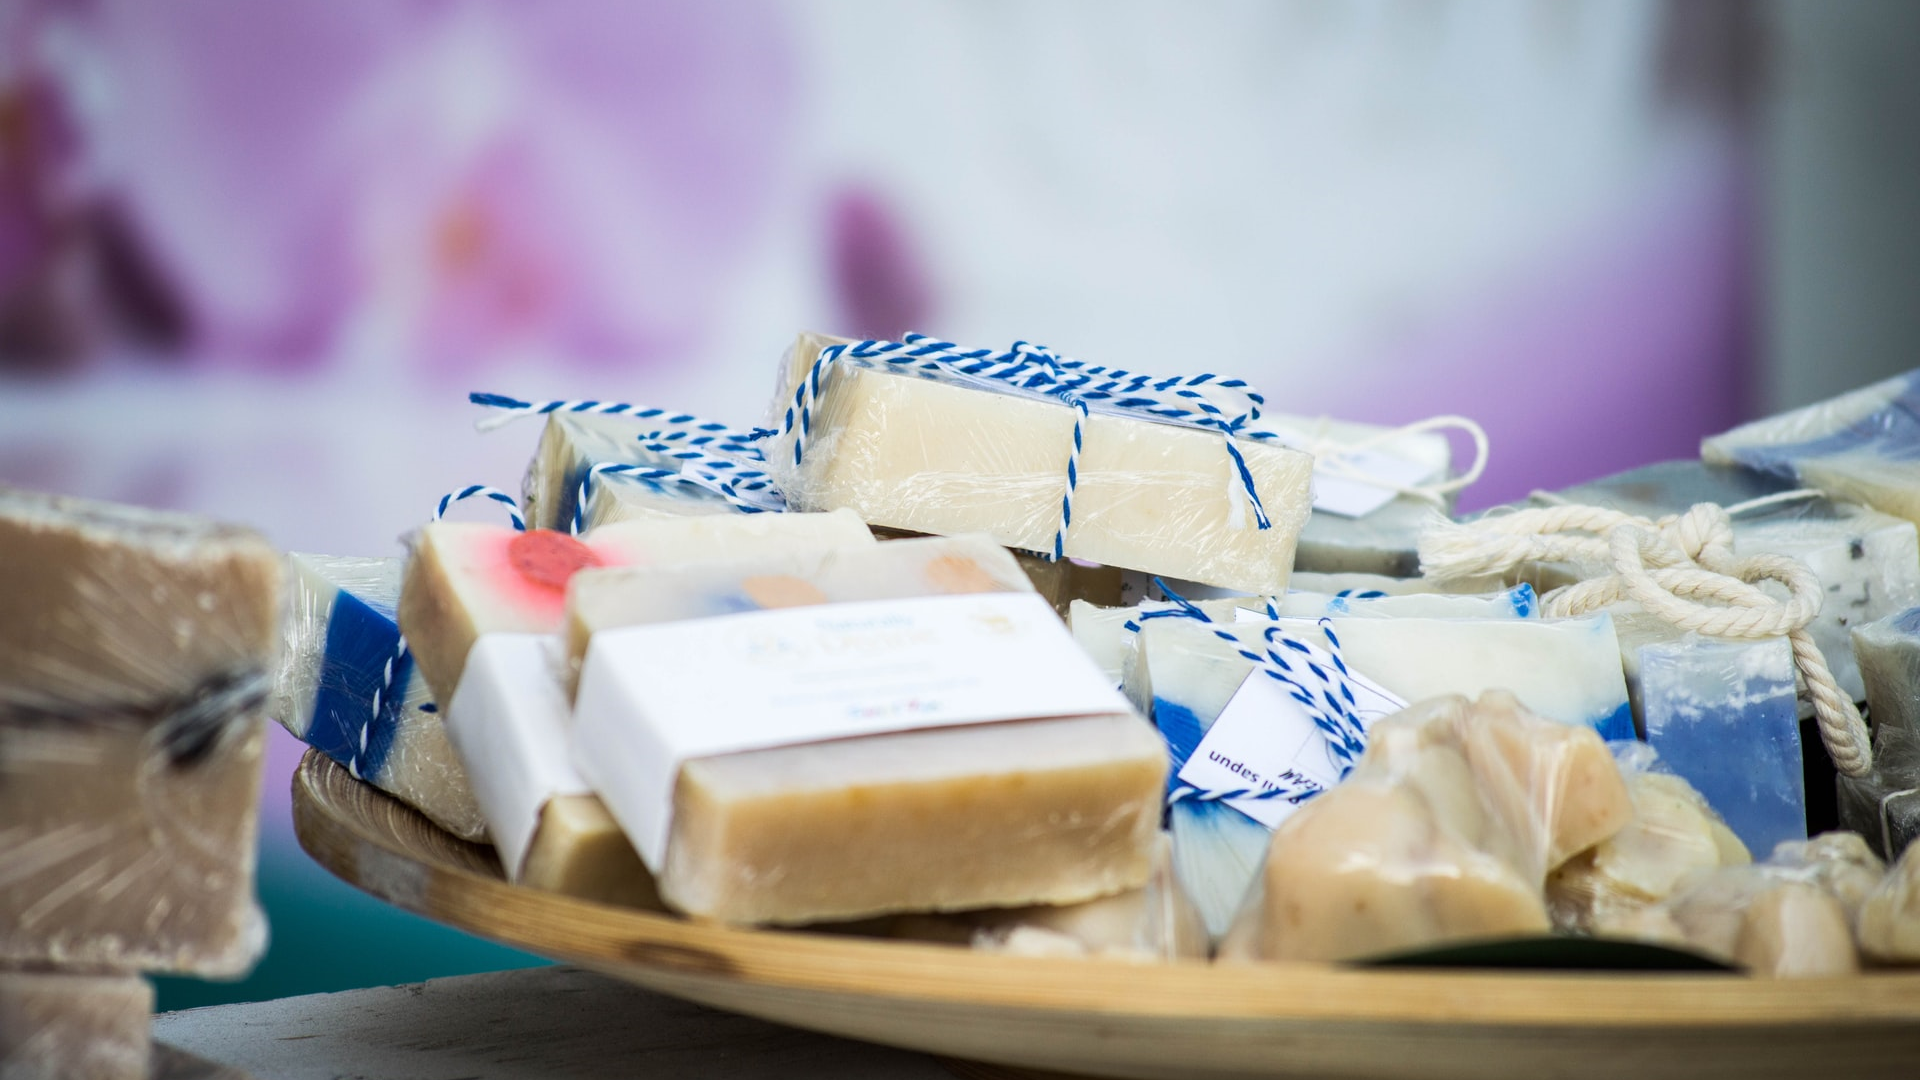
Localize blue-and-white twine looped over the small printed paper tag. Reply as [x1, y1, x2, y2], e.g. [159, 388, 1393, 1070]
[1125, 578, 1367, 805]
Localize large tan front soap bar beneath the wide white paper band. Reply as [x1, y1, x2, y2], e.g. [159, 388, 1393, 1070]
[568, 538, 1165, 924]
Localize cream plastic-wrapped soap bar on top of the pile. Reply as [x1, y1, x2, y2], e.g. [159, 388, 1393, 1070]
[766, 338, 1313, 594]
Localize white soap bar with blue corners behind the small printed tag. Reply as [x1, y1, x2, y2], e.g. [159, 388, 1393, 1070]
[1127, 615, 1630, 934]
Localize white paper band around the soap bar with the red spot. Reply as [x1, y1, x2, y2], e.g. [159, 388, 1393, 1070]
[445, 634, 588, 880]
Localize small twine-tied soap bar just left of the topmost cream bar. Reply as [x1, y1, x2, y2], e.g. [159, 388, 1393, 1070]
[520, 411, 758, 532]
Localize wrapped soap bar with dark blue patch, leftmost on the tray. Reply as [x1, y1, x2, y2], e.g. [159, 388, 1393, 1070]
[269, 553, 486, 842]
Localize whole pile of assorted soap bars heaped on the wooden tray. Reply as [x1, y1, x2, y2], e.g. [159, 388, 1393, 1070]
[232, 334, 1920, 976]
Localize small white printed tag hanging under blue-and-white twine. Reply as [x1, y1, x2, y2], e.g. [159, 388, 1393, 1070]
[1179, 607, 1407, 828]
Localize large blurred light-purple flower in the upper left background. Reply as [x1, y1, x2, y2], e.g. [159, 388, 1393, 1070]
[69, 0, 789, 369]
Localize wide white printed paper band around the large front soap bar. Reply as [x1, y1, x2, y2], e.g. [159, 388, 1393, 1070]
[574, 592, 1129, 871]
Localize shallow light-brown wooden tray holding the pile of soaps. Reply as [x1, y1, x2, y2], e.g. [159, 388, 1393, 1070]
[294, 751, 1920, 1080]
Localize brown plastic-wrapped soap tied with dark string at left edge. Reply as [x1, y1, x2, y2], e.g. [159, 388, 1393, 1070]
[0, 490, 282, 976]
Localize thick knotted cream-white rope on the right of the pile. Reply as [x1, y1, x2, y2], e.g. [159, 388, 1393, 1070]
[1421, 503, 1874, 776]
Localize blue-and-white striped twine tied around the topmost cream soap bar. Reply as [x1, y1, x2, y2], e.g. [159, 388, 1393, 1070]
[751, 334, 1277, 559]
